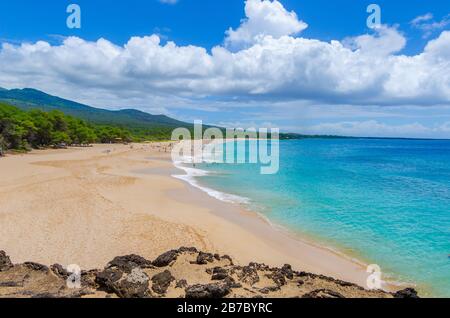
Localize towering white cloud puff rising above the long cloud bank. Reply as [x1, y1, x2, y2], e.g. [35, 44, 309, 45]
[225, 0, 308, 48]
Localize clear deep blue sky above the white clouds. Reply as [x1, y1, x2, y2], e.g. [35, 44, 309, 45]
[0, 0, 450, 54]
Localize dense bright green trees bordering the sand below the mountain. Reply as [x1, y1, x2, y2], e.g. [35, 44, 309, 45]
[0, 103, 134, 151]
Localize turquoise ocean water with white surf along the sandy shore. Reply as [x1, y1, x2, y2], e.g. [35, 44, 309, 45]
[183, 139, 450, 297]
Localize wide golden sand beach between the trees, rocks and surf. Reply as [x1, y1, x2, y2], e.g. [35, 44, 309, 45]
[0, 144, 386, 287]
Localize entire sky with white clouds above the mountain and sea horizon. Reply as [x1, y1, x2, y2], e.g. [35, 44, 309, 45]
[0, 0, 450, 138]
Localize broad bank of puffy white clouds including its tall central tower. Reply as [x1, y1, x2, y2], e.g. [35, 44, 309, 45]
[0, 0, 450, 112]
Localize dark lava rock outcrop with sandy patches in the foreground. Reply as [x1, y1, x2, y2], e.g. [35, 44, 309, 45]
[0, 247, 418, 299]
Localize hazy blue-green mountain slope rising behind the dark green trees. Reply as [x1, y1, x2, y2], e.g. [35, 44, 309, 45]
[0, 88, 192, 132]
